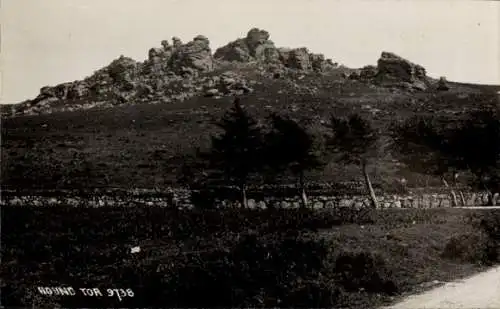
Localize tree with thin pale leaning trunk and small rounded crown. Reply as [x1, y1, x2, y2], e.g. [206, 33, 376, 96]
[326, 114, 380, 208]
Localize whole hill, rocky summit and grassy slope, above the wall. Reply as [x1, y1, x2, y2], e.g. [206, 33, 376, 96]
[1, 29, 500, 192]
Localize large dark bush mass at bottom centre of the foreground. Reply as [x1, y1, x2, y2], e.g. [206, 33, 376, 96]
[158, 235, 338, 307]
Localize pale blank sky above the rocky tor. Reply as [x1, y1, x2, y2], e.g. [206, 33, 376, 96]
[0, 0, 500, 103]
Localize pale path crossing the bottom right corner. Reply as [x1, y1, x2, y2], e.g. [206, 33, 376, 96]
[383, 266, 500, 309]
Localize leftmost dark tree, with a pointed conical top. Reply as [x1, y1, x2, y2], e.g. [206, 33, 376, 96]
[204, 98, 263, 207]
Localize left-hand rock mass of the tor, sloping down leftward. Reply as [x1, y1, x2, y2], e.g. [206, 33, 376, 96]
[27, 35, 215, 112]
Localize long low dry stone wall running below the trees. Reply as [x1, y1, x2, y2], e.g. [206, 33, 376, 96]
[0, 190, 500, 209]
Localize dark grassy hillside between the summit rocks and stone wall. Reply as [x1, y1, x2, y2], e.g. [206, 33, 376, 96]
[1, 65, 498, 188]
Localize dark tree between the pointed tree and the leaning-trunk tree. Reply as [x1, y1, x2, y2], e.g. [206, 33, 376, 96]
[265, 114, 324, 208]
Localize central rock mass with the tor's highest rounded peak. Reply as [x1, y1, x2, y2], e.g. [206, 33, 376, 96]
[214, 28, 333, 71]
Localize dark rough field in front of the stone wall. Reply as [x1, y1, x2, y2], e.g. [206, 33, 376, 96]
[1, 207, 500, 308]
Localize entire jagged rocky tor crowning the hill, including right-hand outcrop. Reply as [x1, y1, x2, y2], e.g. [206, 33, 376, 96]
[8, 28, 447, 114]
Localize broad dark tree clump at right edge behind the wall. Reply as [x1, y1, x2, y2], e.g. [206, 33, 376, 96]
[392, 109, 500, 205]
